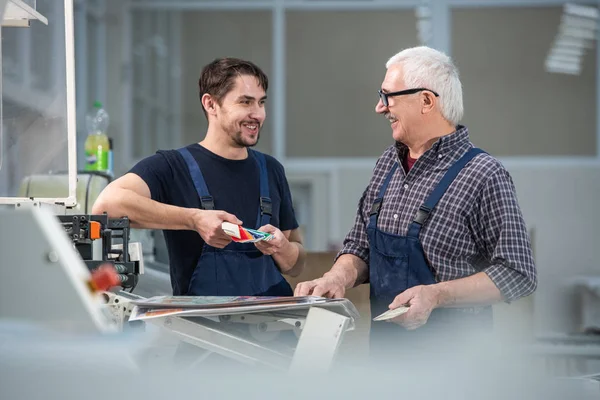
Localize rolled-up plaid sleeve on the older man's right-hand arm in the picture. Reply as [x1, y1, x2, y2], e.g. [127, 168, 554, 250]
[473, 168, 537, 302]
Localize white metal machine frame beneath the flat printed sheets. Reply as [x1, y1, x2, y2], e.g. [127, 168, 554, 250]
[107, 292, 353, 374]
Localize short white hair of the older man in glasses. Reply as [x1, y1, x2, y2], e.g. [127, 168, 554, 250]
[385, 46, 464, 125]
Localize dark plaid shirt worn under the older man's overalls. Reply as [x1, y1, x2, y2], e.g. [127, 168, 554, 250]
[336, 126, 537, 301]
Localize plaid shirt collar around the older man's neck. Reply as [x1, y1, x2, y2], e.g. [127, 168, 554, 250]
[396, 125, 473, 175]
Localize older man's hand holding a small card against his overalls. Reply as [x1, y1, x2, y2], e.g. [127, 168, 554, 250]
[390, 285, 439, 330]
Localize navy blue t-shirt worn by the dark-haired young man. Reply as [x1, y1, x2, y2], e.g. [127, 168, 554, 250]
[129, 143, 298, 296]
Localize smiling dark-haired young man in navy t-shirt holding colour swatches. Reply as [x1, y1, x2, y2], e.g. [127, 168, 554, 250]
[93, 58, 305, 296]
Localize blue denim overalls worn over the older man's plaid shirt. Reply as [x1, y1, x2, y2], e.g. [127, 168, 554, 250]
[367, 148, 492, 357]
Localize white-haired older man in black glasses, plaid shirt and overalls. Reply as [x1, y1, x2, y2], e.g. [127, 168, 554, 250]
[295, 47, 537, 351]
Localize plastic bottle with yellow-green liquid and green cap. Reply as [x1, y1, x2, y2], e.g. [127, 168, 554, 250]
[85, 101, 110, 172]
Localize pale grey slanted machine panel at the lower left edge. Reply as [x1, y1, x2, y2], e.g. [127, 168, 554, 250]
[0, 207, 116, 333]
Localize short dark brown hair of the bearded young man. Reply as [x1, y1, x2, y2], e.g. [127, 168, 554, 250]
[198, 57, 269, 116]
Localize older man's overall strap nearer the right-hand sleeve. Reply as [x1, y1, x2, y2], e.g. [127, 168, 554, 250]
[407, 147, 485, 238]
